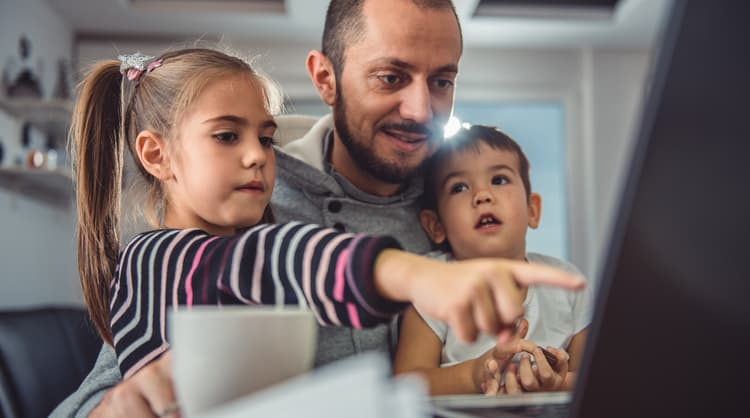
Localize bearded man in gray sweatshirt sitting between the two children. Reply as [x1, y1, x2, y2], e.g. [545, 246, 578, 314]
[52, 0, 462, 416]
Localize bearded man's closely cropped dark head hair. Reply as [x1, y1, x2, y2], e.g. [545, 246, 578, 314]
[322, 0, 463, 79]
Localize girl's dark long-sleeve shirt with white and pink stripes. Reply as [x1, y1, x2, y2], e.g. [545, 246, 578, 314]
[110, 223, 405, 378]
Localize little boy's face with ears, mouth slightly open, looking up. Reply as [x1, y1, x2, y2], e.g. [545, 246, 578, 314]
[420, 141, 541, 260]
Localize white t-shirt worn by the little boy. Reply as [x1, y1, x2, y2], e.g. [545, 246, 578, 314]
[418, 253, 593, 367]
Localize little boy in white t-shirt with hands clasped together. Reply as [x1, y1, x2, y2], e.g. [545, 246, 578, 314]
[394, 125, 591, 395]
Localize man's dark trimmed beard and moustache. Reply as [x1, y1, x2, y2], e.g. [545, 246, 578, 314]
[333, 85, 434, 184]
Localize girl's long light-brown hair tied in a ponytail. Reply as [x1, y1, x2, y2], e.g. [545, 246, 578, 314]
[70, 48, 281, 344]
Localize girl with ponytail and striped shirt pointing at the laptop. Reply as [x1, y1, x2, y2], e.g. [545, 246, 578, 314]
[71, 49, 582, 378]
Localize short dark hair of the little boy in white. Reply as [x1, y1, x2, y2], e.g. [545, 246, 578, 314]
[422, 125, 531, 211]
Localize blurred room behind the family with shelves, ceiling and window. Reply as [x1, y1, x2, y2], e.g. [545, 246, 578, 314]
[0, 0, 670, 414]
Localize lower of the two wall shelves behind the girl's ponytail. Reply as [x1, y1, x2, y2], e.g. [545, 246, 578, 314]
[0, 168, 73, 207]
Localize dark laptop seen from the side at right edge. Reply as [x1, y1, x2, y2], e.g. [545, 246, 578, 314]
[433, 0, 750, 418]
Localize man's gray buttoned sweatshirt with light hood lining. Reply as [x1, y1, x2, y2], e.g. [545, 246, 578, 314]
[50, 115, 430, 417]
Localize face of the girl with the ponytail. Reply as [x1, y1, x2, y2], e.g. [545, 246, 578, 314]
[165, 74, 276, 235]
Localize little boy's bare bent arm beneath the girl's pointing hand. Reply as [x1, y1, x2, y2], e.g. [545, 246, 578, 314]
[393, 308, 480, 396]
